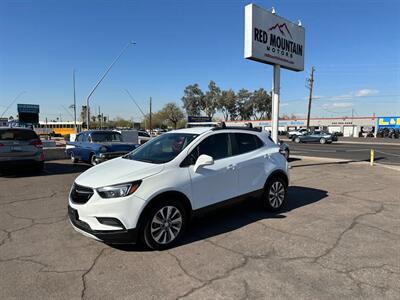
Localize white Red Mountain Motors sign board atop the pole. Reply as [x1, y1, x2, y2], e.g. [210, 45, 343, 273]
[244, 4, 305, 71]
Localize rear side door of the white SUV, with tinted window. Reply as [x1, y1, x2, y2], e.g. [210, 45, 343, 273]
[233, 133, 268, 195]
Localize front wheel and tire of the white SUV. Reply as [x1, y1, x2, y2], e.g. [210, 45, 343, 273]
[141, 199, 188, 250]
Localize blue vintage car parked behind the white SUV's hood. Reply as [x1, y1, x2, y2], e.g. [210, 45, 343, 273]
[65, 130, 139, 166]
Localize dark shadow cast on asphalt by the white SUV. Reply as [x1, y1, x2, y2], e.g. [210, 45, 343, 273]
[110, 186, 328, 252]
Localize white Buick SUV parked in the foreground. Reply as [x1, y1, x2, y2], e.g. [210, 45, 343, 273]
[68, 127, 289, 249]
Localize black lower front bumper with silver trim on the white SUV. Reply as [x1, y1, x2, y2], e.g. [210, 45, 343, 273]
[68, 205, 138, 244]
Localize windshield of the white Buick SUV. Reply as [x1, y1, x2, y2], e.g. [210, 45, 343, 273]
[124, 133, 198, 164]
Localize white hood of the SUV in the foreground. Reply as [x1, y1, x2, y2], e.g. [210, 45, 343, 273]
[75, 157, 164, 188]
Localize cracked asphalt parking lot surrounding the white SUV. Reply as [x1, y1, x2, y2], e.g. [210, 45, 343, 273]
[0, 159, 400, 299]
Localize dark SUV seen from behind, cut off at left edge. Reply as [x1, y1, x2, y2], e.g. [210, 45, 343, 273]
[0, 127, 44, 171]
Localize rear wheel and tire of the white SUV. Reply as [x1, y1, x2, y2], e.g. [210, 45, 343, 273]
[261, 176, 287, 211]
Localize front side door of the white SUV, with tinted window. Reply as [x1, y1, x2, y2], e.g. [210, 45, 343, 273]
[188, 133, 239, 209]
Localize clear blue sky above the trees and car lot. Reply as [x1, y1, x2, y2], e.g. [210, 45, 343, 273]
[0, 0, 400, 120]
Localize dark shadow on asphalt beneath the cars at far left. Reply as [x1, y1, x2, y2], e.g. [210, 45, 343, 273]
[0, 161, 90, 178]
